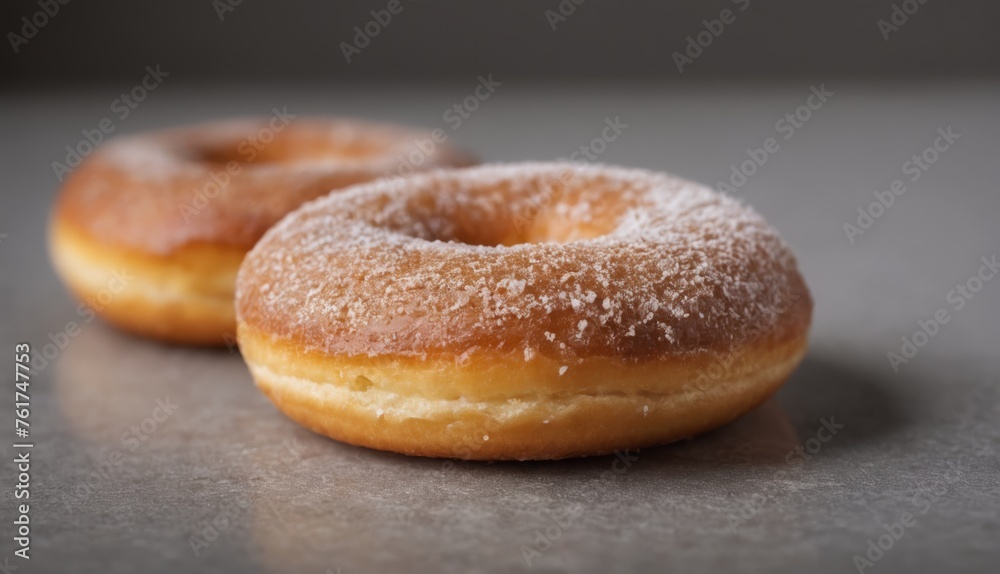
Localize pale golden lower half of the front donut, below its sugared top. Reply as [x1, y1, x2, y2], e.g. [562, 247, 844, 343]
[238, 324, 806, 460]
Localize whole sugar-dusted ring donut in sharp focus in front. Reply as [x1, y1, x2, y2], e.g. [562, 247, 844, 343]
[236, 163, 812, 460]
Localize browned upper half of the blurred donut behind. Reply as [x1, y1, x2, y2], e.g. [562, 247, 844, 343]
[55, 114, 472, 254]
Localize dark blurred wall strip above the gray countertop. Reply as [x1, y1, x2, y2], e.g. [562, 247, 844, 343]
[0, 0, 1000, 84]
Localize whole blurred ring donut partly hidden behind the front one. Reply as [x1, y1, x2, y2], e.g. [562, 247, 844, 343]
[49, 114, 471, 345]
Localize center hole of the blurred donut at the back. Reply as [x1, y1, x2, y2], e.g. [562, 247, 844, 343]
[192, 135, 384, 166]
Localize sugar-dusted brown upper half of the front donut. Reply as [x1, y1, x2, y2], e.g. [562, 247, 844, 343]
[237, 160, 812, 360]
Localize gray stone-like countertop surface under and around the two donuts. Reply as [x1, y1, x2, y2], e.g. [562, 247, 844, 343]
[0, 82, 1000, 574]
